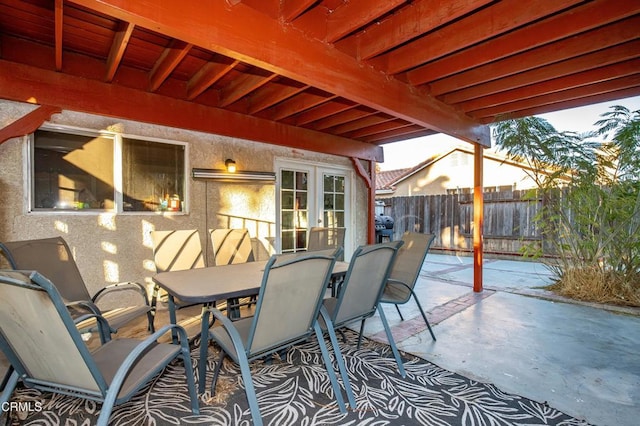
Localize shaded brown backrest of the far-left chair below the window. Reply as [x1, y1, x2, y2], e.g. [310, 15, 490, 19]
[0, 237, 91, 301]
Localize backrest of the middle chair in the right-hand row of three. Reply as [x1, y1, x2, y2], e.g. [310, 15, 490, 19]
[332, 240, 403, 326]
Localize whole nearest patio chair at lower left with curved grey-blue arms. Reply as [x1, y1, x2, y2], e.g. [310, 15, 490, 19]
[0, 270, 199, 426]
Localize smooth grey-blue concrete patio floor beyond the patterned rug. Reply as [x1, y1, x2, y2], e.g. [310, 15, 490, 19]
[365, 254, 640, 426]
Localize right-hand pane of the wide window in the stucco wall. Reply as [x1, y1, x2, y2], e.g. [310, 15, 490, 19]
[122, 138, 185, 211]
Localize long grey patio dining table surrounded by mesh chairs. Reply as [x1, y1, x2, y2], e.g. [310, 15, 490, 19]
[153, 261, 349, 393]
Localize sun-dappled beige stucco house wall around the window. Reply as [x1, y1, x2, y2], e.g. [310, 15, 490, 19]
[0, 101, 367, 304]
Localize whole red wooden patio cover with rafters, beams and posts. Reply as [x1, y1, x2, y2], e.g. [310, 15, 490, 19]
[0, 0, 640, 292]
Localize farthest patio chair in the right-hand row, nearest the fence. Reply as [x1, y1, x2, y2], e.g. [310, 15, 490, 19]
[380, 231, 436, 341]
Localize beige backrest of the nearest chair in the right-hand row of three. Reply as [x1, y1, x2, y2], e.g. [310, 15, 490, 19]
[246, 249, 341, 358]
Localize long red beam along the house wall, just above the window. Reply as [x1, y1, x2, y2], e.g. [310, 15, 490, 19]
[0, 59, 384, 161]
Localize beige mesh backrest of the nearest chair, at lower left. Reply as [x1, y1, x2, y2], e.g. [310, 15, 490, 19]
[0, 270, 106, 397]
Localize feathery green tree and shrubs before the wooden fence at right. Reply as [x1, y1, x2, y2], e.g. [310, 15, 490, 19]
[493, 106, 640, 306]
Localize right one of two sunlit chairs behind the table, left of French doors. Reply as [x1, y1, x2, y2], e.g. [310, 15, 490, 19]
[209, 228, 256, 319]
